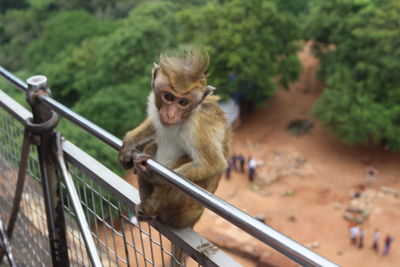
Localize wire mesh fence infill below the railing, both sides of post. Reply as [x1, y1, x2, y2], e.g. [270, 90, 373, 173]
[0, 93, 211, 267]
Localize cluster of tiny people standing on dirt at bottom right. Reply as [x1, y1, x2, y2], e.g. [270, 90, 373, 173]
[349, 223, 393, 256]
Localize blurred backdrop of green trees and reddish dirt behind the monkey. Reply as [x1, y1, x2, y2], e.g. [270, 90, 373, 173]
[0, 0, 400, 266]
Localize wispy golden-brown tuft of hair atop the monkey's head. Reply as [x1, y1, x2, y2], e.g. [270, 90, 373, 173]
[160, 47, 210, 93]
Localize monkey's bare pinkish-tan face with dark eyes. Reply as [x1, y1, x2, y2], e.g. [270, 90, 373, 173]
[156, 87, 197, 127]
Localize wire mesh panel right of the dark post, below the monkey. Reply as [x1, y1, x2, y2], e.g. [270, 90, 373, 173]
[61, 163, 198, 266]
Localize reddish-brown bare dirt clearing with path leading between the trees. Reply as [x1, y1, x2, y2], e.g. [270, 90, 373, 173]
[195, 43, 400, 267]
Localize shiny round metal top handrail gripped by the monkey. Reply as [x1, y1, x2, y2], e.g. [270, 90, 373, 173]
[0, 67, 338, 266]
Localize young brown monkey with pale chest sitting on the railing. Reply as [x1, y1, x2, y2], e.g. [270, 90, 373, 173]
[119, 48, 231, 228]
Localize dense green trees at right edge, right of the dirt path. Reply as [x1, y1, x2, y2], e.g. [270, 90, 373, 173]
[306, 0, 400, 149]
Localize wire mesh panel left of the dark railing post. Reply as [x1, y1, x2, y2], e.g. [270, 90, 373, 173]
[0, 109, 51, 266]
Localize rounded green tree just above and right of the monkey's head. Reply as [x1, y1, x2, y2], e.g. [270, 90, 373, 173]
[179, 0, 300, 104]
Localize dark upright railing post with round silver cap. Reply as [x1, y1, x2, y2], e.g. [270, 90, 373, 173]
[27, 75, 69, 267]
